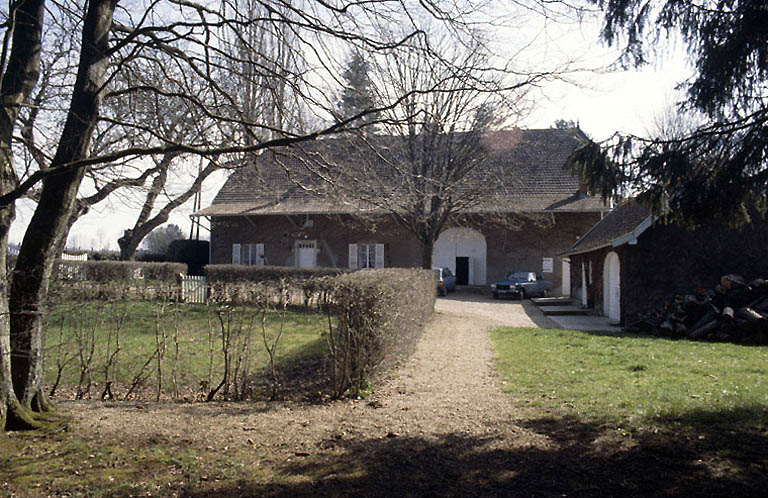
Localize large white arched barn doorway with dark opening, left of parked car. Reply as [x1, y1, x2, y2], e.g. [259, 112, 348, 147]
[432, 228, 487, 285]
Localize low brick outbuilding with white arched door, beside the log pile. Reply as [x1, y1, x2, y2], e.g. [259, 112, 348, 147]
[560, 199, 768, 325]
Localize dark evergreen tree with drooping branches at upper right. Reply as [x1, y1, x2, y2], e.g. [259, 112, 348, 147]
[573, 0, 768, 226]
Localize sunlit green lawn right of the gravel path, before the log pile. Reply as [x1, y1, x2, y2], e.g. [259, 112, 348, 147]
[492, 328, 768, 431]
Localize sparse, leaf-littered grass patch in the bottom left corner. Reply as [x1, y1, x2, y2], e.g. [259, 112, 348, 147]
[0, 432, 260, 497]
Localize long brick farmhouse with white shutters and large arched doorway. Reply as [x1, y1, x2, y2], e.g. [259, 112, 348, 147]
[196, 129, 608, 289]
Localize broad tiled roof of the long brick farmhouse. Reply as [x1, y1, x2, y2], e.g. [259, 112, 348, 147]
[196, 129, 607, 216]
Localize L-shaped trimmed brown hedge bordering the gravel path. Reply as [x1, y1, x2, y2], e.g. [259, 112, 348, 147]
[201, 265, 436, 397]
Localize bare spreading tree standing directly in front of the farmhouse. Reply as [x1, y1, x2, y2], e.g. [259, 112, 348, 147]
[284, 37, 546, 268]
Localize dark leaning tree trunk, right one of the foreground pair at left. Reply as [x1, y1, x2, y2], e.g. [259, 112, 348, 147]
[9, 0, 116, 411]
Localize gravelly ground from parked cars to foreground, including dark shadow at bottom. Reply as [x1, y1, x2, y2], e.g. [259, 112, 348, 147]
[62, 294, 760, 497]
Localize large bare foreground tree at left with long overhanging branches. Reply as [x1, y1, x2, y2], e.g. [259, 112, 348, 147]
[0, 0, 520, 427]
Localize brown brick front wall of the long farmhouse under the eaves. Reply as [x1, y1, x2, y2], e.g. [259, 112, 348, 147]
[211, 213, 600, 289]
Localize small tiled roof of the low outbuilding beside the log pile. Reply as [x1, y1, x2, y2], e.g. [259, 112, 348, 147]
[560, 199, 651, 256]
